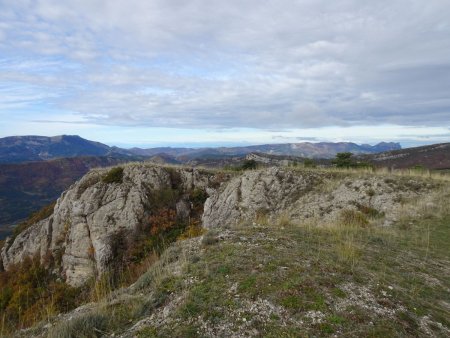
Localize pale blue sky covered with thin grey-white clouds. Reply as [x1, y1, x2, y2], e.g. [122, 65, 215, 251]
[0, 0, 450, 147]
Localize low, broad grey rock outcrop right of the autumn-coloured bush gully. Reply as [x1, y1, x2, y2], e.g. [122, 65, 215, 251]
[203, 168, 431, 228]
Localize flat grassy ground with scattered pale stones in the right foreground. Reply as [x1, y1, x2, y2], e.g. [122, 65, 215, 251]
[154, 217, 450, 337]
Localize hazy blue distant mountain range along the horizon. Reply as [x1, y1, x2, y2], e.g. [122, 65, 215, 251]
[0, 135, 401, 163]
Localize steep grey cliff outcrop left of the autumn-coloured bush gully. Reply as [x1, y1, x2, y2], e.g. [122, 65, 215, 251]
[1, 164, 213, 285]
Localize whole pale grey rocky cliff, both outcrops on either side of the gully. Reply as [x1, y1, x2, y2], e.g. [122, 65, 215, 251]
[1, 164, 433, 285]
